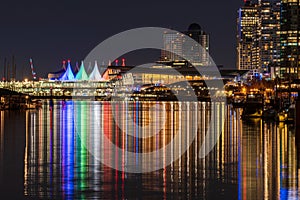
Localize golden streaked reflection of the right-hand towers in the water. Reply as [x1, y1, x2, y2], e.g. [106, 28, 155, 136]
[238, 116, 299, 199]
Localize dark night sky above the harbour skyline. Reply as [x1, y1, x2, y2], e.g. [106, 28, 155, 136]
[0, 0, 243, 77]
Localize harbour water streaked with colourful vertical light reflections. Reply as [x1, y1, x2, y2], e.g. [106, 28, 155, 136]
[0, 101, 300, 199]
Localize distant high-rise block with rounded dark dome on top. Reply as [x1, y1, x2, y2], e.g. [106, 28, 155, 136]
[161, 23, 209, 66]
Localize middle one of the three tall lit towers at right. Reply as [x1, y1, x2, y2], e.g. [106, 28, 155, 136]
[259, 0, 280, 78]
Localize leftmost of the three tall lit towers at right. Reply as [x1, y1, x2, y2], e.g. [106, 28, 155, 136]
[237, 0, 261, 70]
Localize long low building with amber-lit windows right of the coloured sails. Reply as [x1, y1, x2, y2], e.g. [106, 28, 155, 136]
[103, 65, 248, 85]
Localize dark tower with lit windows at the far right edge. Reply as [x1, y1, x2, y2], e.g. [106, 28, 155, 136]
[280, 0, 300, 79]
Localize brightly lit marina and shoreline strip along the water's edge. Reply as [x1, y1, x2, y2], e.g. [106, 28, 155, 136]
[0, 76, 299, 122]
